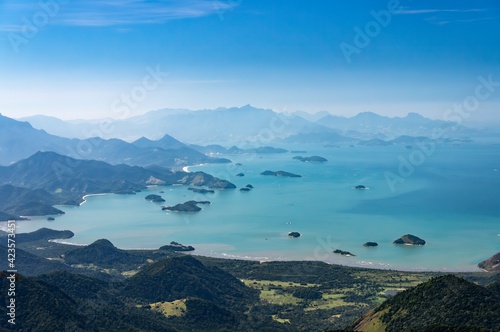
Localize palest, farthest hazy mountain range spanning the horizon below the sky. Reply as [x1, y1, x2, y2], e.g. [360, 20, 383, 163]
[16, 105, 475, 145]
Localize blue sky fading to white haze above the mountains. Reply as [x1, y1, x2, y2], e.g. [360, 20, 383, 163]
[0, 0, 500, 123]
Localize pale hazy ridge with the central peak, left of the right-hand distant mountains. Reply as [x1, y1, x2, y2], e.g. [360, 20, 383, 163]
[18, 105, 321, 144]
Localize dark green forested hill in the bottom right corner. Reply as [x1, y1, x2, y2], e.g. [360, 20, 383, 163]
[354, 275, 500, 332]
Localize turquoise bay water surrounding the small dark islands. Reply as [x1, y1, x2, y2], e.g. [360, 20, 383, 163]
[4, 144, 500, 271]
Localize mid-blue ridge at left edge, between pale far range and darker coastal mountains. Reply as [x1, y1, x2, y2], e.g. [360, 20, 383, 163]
[0, 115, 230, 167]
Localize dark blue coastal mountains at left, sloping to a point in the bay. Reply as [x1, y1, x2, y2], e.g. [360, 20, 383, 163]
[0, 152, 236, 220]
